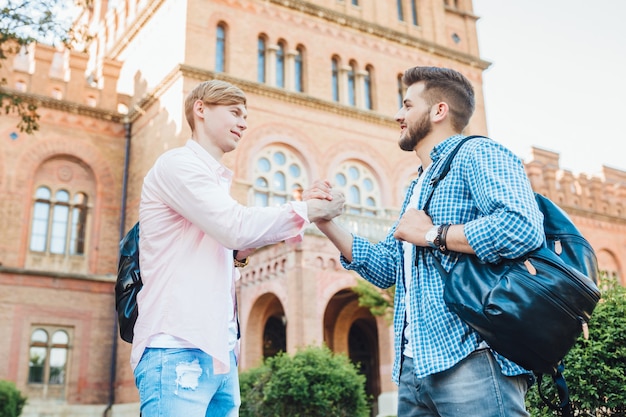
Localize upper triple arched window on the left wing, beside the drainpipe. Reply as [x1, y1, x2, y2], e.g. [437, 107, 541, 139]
[29, 186, 88, 255]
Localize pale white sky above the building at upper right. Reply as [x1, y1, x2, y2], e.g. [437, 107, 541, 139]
[473, 0, 626, 175]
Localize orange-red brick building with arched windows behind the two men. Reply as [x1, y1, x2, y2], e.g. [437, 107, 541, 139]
[0, 0, 626, 416]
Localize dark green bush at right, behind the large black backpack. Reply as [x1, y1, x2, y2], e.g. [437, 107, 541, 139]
[526, 279, 626, 417]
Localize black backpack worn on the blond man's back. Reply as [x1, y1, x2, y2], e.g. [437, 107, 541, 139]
[115, 222, 143, 343]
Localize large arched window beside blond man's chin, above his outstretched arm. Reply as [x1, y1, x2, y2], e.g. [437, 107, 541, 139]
[253, 146, 308, 207]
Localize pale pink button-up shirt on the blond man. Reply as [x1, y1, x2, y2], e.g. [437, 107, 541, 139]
[131, 139, 309, 369]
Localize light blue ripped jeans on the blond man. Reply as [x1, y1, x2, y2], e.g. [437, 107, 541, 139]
[135, 348, 241, 417]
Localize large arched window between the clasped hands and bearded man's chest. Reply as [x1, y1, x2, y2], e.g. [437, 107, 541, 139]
[335, 161, 380, 216]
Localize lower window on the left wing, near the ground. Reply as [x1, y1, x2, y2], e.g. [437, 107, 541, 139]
[28, 327, 70, 385]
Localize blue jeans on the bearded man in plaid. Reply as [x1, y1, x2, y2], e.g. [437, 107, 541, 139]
[398, 349, 529, 417]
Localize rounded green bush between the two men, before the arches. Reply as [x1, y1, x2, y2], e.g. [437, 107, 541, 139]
[239, 347, 369, 417]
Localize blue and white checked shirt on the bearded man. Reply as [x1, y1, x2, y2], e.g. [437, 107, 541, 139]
[341, 135, 543, 383]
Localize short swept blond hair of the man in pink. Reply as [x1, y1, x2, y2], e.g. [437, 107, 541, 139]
[185, 80, 246, 131]
